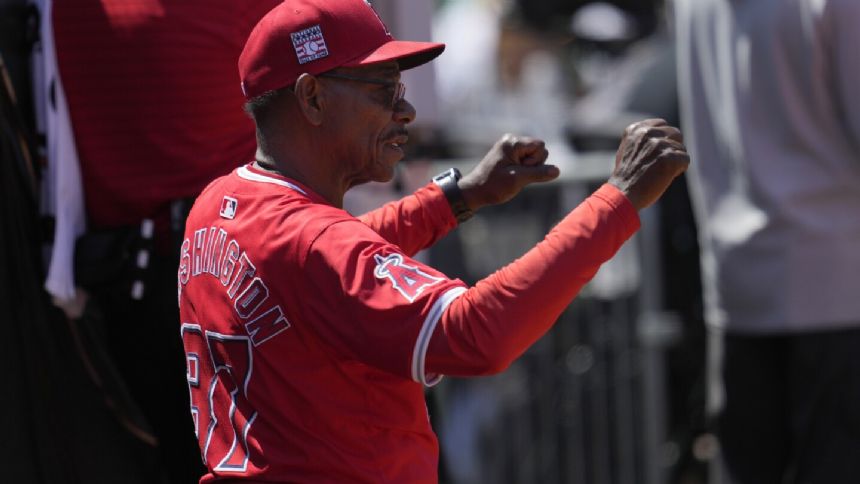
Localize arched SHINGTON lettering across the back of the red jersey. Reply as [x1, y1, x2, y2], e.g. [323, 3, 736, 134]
[178, 227, 290, 346]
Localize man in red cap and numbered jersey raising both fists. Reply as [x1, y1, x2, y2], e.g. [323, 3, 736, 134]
[178, 0, 689, 483]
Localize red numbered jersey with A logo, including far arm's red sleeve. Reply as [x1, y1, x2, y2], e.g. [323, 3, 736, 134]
[178, 165, 466, 482]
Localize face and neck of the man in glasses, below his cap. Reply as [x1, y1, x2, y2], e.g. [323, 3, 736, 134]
[252, 61, 416, 207]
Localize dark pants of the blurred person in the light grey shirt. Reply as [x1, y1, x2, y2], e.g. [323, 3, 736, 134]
[710, 329, 860, 484]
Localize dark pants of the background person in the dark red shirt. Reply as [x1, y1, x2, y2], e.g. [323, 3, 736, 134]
[76, 218, 204, 484]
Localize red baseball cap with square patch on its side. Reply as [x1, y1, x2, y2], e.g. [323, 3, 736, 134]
[239, 0, 445, 99]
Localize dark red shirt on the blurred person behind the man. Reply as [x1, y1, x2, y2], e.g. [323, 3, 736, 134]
[53, 0, 280, 227]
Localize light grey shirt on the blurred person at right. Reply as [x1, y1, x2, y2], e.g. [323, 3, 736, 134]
[675, 0, 860, 333]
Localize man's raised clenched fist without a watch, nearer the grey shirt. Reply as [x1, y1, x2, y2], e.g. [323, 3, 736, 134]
[609, 119, 690, 210]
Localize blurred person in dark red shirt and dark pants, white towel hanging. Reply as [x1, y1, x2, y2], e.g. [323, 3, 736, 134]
[42, 0, 278, 483]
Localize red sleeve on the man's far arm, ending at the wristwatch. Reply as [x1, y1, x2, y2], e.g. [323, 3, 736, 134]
[359, 183, 457, 256]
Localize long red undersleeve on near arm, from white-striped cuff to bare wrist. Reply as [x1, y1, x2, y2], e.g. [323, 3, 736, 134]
[426, 184, 639, 375]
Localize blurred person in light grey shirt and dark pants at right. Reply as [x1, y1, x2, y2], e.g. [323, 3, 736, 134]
[675, 0, 860, 484]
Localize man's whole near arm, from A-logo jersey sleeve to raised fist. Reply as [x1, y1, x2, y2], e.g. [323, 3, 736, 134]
[301, 120, 689, 385]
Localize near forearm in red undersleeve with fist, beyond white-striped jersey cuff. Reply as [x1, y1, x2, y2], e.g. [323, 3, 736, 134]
[421, 120, 689, 376]
